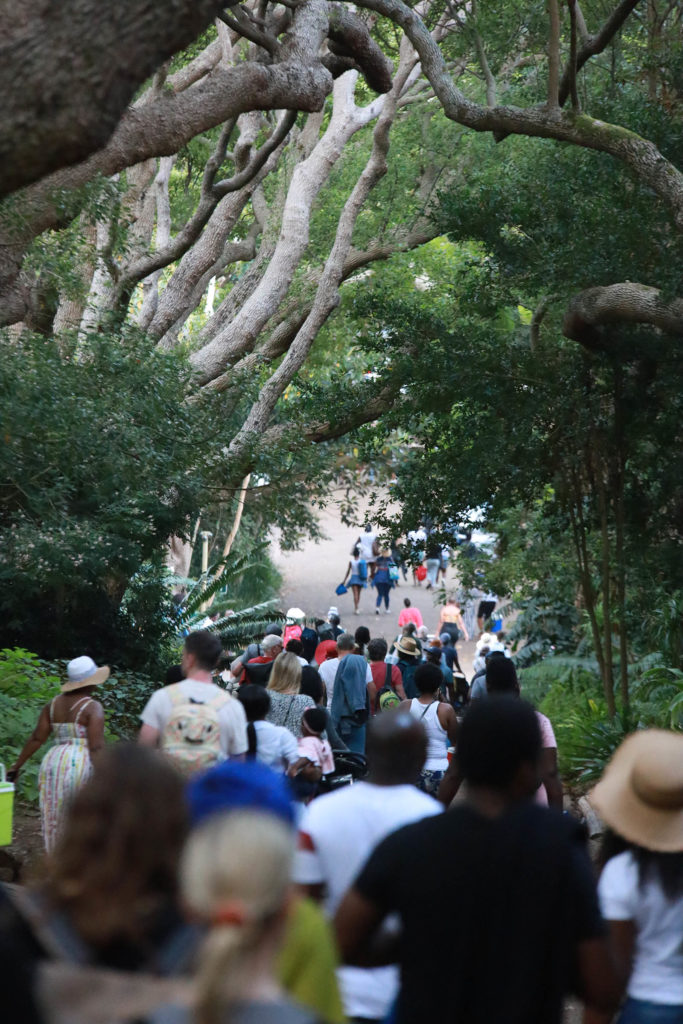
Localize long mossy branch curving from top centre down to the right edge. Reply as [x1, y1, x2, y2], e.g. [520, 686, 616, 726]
[357, 0, 683, 230]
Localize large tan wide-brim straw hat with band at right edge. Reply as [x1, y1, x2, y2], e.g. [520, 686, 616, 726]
[588, 729, 683, 853]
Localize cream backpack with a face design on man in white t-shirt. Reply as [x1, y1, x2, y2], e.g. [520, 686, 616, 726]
[161, 683, 230, 776]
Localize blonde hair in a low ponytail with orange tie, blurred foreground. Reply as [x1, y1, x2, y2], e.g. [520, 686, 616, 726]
[180, 811, 294, 1024]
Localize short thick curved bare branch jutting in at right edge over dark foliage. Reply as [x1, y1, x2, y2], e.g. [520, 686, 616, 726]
[562, 281, 683, 348]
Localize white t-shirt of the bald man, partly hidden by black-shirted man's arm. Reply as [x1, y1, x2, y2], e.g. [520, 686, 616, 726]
[294, 782, 443, 1020]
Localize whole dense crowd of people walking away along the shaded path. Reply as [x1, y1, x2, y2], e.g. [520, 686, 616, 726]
[5, 606, 683, 1024]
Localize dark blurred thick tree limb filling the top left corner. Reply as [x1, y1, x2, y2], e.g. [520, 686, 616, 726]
[0, 0, 229, 196]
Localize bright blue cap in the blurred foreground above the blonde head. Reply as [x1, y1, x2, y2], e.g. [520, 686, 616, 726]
[187, 761, 295, 825]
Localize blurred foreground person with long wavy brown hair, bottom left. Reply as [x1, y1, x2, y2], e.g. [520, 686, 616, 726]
[0, 743, 194, 1024]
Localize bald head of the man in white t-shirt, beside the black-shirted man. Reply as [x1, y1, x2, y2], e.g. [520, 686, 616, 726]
[366, 711, 427, 785]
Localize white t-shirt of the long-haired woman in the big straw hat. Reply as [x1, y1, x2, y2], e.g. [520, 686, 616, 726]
[598, 852, 683, 1007]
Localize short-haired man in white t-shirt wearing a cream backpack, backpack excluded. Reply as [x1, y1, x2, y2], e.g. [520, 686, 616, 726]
[138, 630, 248, 760]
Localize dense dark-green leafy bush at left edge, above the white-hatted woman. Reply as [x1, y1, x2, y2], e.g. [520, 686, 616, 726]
[0, 332, 218, 667]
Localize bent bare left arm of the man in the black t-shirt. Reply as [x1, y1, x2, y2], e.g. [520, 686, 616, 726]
[334, 888, 398, 967]
